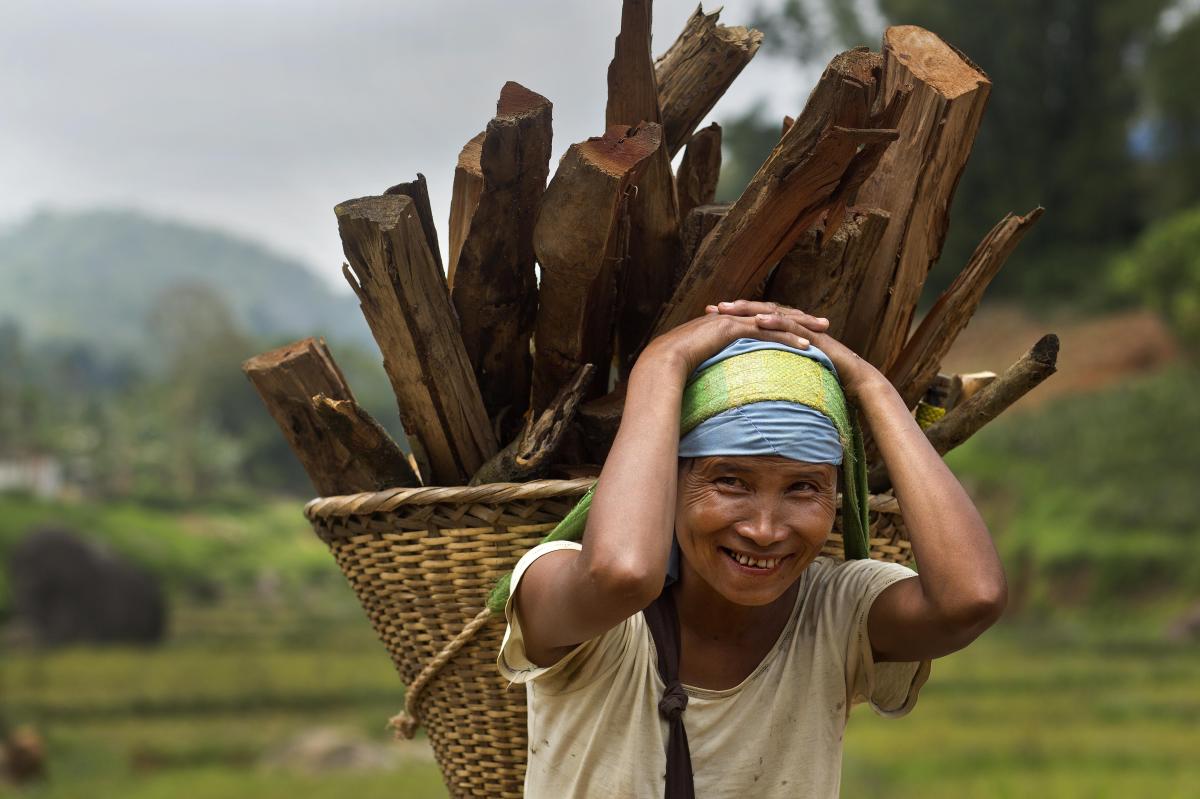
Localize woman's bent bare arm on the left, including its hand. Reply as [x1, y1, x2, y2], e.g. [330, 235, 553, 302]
[515, 313, 822, 666]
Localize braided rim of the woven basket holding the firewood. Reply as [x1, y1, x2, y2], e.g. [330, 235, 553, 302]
[304, 477, 900, 522]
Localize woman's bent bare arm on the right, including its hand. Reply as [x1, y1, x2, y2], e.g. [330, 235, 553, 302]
[719, 301, 1008, 661]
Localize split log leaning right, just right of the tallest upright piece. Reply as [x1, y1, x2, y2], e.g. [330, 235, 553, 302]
[654, 6, 762, 158]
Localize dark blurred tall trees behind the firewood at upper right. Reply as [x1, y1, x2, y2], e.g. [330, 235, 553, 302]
[720, 0, 1200, 305]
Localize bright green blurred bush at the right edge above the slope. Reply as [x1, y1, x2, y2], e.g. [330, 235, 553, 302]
[1109, 205, 1200, 355]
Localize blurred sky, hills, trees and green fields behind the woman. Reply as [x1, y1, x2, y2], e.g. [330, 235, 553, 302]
[0, 0, 1200, 799]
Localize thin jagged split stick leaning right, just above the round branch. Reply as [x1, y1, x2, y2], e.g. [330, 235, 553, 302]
[887, 208, 1042, 408]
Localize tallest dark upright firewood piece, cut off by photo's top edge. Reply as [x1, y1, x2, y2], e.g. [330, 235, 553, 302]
[605, 0, 679, 374]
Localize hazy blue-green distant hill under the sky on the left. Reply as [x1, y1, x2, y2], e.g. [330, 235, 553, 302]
[0, 210, 373, 364]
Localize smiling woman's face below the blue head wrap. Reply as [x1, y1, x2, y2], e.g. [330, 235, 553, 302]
[676, 455, 838, 606]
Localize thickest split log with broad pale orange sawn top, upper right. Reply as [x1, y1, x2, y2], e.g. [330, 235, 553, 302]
[845, 25, 991, 373]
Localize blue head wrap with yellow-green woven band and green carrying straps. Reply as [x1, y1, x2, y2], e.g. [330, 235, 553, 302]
[488, 338, 869, 612]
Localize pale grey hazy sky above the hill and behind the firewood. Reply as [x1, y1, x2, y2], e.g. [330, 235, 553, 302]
[0, 0, 870, 289]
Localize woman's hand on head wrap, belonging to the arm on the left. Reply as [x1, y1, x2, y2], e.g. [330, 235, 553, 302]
[635, 305, 829, 379]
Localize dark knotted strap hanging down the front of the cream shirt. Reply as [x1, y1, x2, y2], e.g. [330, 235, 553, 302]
[642, 589, 696, 799]
